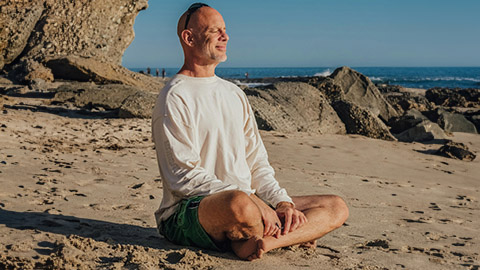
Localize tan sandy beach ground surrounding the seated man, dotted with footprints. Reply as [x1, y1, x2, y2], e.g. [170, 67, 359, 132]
[0, 92, 480, 269]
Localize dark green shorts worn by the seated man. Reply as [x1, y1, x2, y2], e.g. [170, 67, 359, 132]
[158, 196, 222, 251]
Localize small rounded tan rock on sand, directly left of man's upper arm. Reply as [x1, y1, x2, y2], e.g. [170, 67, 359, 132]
[118, 91, 157, 118]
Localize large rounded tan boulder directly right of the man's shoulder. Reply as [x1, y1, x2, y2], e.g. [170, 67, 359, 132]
[245, 82, 345, 134]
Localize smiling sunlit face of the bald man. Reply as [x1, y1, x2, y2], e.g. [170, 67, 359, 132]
[193, 7, 229, 64]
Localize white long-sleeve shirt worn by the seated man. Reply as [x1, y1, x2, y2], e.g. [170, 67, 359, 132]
[152, 74, 292, 223]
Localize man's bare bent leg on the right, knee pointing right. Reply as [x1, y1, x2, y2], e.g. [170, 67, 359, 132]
[248, 195, 348, 260]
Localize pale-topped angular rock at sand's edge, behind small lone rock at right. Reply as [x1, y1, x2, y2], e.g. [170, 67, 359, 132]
[395, 120, 447, 142]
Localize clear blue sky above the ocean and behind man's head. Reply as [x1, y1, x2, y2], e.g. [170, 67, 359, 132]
[123, 0, 480, 68]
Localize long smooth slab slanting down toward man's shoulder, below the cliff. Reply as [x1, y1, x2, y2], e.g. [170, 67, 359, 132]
[46, 56, 164, 93]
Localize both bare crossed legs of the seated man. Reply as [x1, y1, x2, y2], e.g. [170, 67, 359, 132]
[198, 191, 348, 260]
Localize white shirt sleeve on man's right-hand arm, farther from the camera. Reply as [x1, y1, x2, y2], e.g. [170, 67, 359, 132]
[244, 96, 293, 207]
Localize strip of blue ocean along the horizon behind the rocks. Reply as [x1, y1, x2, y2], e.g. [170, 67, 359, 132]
[130, 67, 480, 89]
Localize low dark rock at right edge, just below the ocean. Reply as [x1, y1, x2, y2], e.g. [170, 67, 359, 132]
[425, 88, 480, 108]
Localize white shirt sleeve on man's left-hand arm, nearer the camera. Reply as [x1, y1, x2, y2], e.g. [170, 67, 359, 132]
[153, 93, 251, 198]
